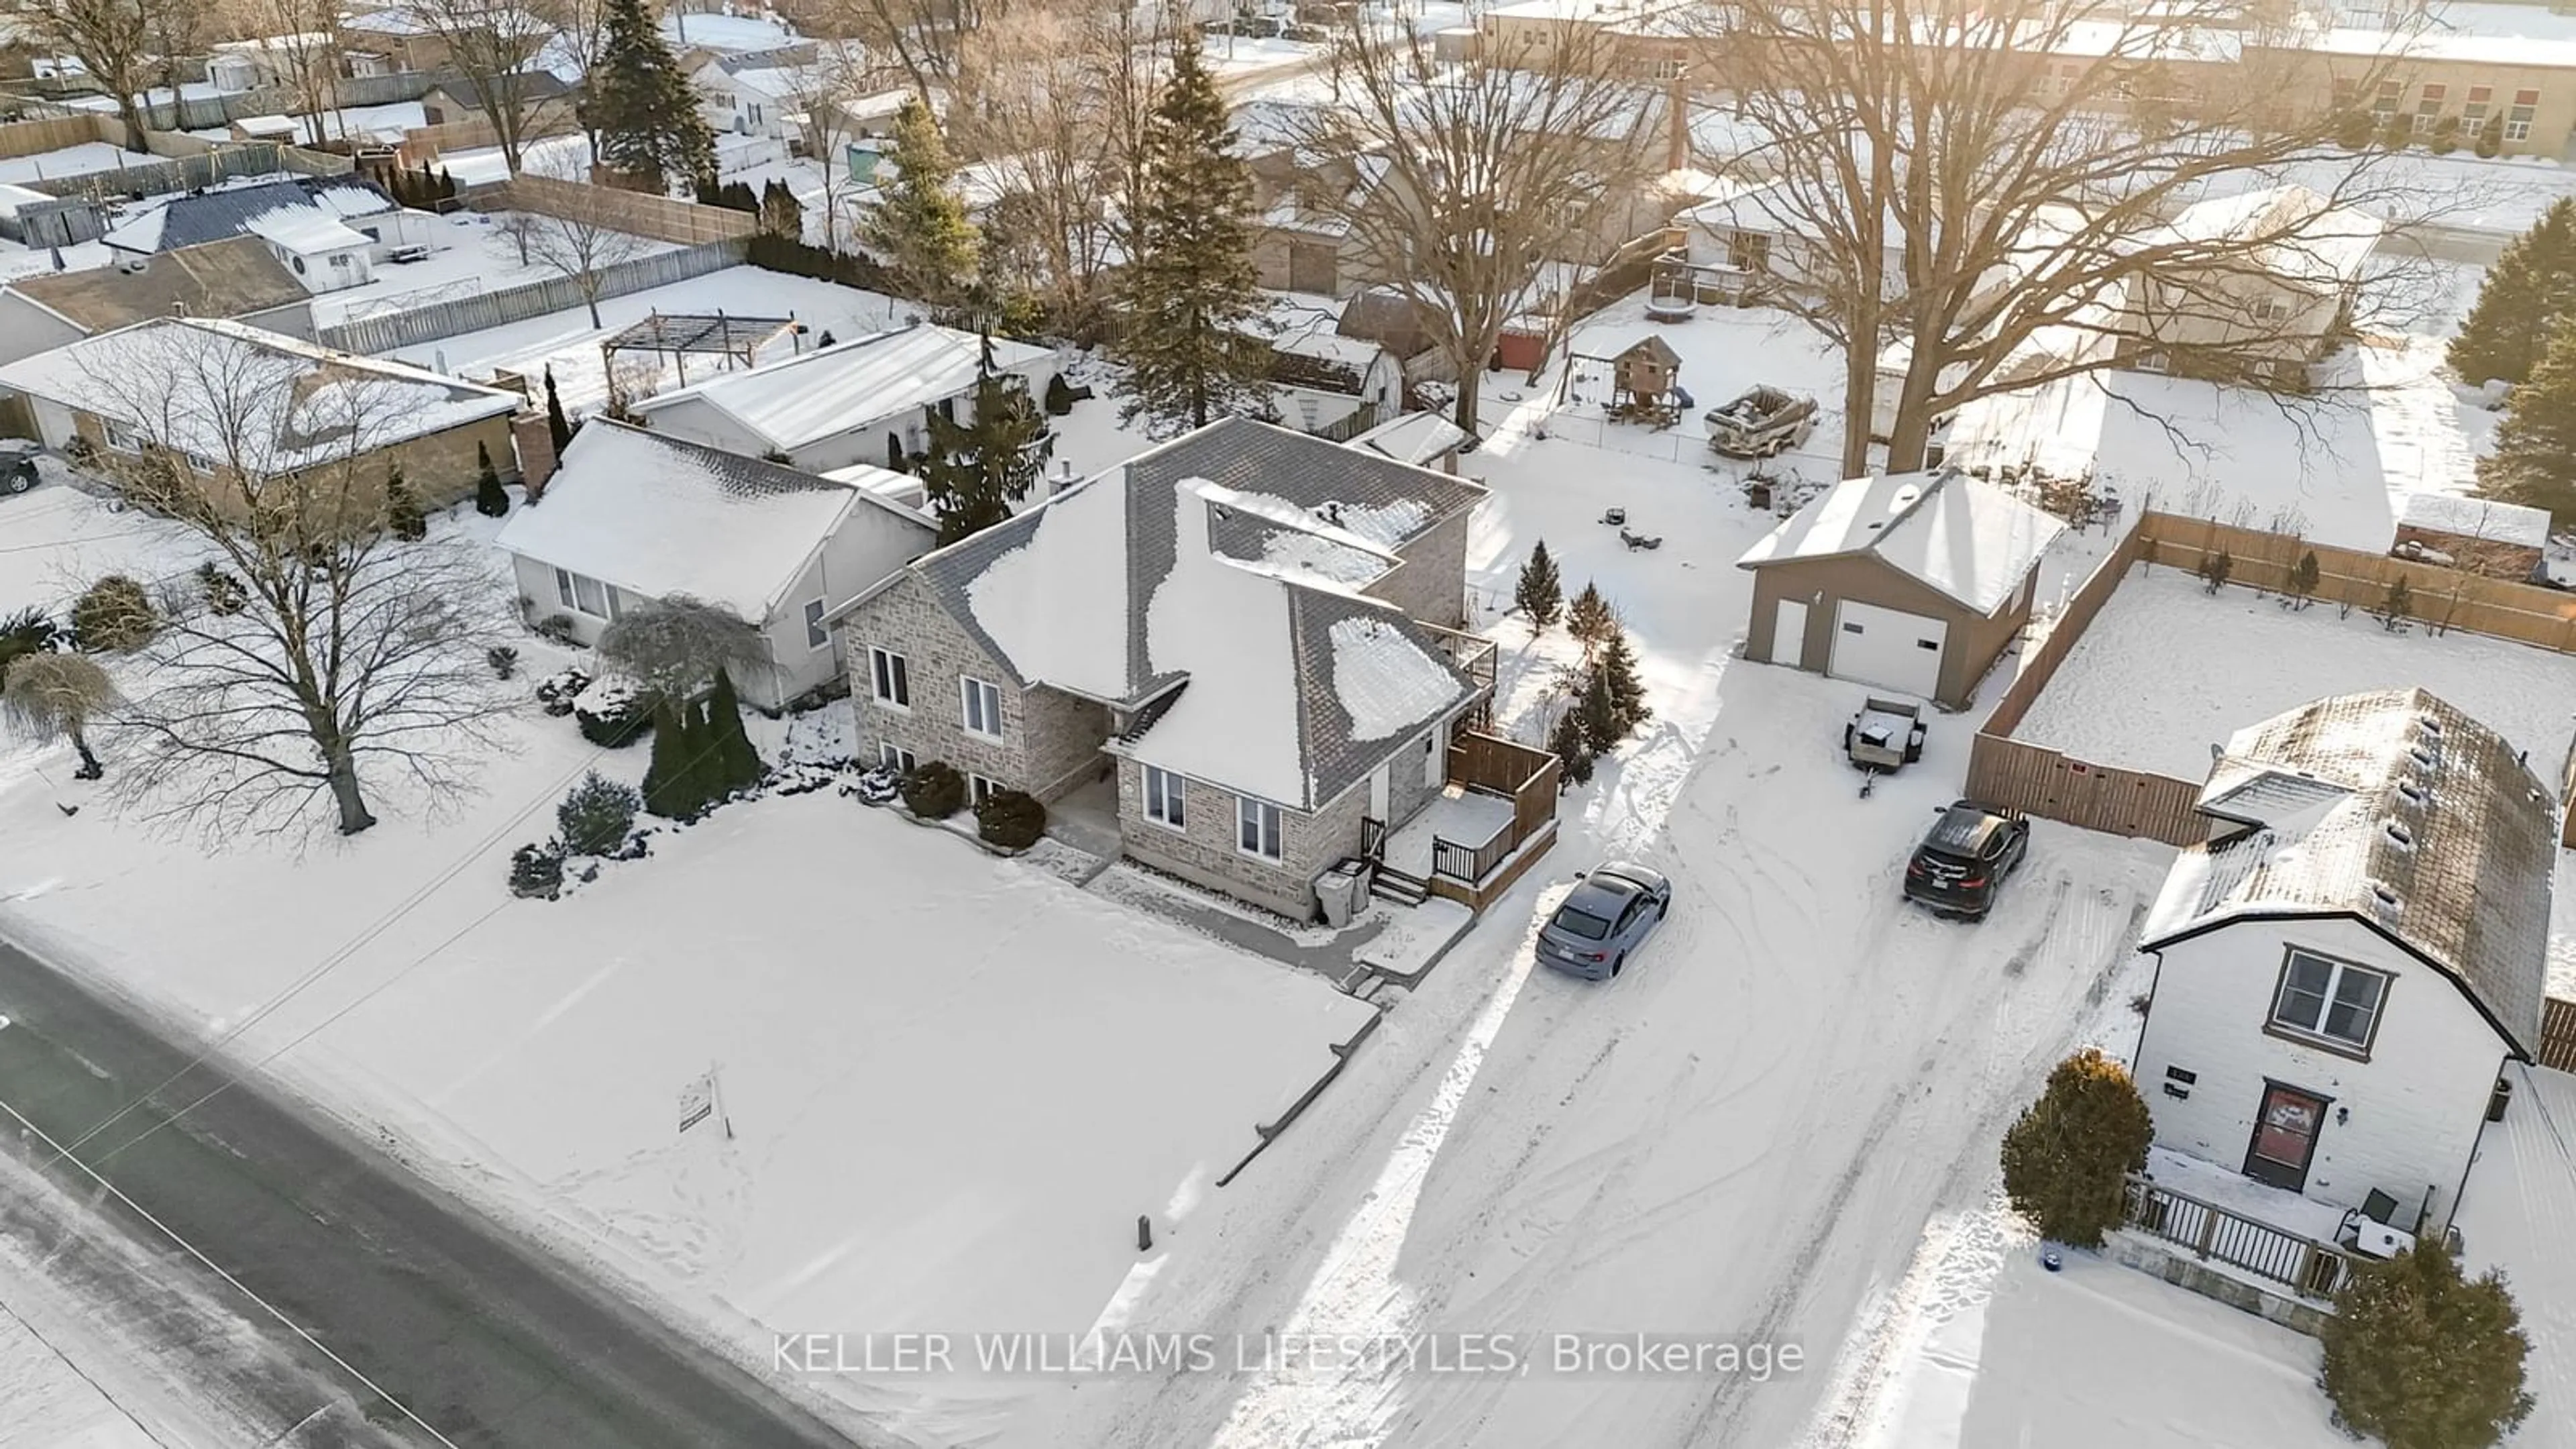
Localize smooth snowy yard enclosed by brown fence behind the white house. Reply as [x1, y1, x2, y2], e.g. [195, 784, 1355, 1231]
[2012, 565, 2576, 779]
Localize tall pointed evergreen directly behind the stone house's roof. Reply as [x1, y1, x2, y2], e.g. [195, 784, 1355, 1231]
[1120, 36, 1270, 433]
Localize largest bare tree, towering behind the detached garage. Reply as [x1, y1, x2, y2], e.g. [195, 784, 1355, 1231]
[1703, 0, 2439, 474]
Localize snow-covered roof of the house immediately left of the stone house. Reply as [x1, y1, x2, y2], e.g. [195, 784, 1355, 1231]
[497, 418, 935, 624]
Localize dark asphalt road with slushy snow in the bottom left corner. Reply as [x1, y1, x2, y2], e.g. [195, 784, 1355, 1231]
[0, 928, 865, 1449]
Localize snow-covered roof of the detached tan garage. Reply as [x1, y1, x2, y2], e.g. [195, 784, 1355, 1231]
[1736, 472, 2066, 616]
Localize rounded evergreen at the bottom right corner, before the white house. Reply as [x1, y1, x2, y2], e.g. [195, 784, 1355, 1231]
[2318, 1238, 2563, 1449]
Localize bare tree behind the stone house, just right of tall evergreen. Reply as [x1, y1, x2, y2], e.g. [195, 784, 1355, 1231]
[1291, 15, 1669, 431]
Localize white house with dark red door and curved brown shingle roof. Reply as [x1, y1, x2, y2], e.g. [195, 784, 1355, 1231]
[2138, 688, 2558, 1232]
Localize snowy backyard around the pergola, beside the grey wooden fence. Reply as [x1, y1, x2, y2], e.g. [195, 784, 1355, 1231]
[384, 265, 907, 413]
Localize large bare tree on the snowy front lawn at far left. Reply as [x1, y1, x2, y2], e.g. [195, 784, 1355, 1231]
[80, 322, 507, 838]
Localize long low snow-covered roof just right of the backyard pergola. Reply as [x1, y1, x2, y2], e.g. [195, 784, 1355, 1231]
[636, 322, 1049, 451]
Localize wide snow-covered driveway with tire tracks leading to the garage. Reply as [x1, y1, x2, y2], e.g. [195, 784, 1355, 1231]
[1030, 660, 2166, 1449]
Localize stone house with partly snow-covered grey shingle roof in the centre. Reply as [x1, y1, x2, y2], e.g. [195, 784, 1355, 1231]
[840, 418, 1491, 918]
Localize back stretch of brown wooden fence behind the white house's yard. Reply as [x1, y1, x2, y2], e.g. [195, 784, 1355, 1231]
[2138, 511, 2576, 652]
